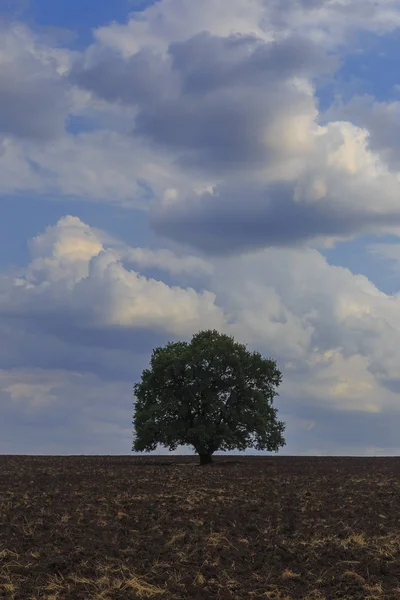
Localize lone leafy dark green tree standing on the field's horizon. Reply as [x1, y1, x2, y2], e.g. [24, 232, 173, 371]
[132, 330, 286, 465]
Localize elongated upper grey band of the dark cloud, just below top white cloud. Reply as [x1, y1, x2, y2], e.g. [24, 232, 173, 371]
[69, 31, 338, 106]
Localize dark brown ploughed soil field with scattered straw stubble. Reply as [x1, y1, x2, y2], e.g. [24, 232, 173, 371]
[0, 455, 400, 600]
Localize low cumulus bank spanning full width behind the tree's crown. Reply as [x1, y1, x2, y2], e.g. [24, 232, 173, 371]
[0, 216, 400, 453]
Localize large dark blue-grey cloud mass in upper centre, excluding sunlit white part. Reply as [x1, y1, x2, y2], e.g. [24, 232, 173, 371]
[70, 32, 336, 174]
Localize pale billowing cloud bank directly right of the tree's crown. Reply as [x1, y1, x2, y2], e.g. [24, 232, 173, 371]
[211, 248, 400, 416]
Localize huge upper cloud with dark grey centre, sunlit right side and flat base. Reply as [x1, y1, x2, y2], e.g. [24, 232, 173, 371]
[71, 10, 400, 254]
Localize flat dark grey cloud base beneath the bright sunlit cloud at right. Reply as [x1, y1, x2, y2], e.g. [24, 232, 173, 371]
[151, 183, 400, 254]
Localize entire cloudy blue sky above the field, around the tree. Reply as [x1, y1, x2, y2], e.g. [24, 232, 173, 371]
[0, 0, 400, 456]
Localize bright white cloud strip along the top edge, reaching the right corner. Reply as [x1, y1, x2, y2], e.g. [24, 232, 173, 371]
[95, 0, 400, 56]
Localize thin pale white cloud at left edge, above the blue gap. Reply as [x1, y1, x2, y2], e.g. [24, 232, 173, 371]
[0, 130, 212, 210]
